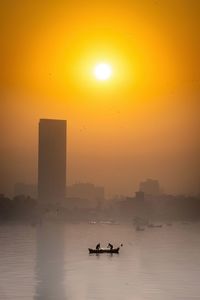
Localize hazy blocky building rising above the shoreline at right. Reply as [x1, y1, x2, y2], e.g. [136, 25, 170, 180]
[139, 179, 161, 196]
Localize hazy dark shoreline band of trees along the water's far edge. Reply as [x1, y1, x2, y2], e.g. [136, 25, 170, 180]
[0, 194, 200, 224]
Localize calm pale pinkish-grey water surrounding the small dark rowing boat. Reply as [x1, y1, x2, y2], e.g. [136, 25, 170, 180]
[0, 223, 200, 300]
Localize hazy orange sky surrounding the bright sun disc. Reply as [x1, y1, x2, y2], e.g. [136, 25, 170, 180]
[0, 0, 200, 195]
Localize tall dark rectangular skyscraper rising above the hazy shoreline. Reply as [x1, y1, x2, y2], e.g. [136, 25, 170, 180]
[38, 119, 67, 205]
